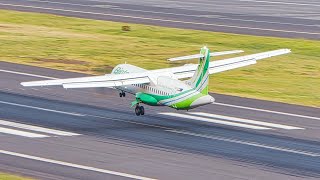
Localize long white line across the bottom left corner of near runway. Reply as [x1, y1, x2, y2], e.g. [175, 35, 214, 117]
[0, 150, 155, 180]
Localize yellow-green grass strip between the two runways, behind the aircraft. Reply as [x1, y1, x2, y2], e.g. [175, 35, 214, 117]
[0, 10, 320, 107]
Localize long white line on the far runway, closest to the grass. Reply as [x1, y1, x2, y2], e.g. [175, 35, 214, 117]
[0, 3, 320, 35]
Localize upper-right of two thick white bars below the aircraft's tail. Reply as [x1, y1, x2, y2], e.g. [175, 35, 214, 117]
[189, 112, 304, 130]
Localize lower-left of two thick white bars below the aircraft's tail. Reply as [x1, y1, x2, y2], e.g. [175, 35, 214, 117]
[159, 112, 271, 130]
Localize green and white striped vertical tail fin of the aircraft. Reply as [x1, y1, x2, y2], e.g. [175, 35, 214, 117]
[189, 46, 210, 95]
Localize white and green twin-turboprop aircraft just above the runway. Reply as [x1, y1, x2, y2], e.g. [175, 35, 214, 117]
[21, 47, 291, 116]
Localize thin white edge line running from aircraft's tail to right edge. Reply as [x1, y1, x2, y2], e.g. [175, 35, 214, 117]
[212, 102, 320, 120]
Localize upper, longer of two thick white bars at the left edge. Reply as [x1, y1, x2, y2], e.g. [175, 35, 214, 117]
[0, 120, 80, 136]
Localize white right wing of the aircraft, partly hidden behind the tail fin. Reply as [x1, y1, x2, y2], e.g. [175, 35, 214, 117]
[164, 49, 291, 79]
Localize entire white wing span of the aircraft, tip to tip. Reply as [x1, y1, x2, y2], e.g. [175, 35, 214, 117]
[21, 49, 291, 88]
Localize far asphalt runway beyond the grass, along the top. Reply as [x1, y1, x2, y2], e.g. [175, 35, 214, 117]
[0, 0, 320, 39]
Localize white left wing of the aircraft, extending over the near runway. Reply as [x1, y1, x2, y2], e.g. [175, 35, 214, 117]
[21, 73, 150, 88]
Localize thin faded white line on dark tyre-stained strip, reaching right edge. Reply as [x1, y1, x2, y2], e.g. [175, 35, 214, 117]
[165, 130, 320, 157]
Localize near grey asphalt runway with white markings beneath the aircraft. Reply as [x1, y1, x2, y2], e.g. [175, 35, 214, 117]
[0, 62, 320, 180]
